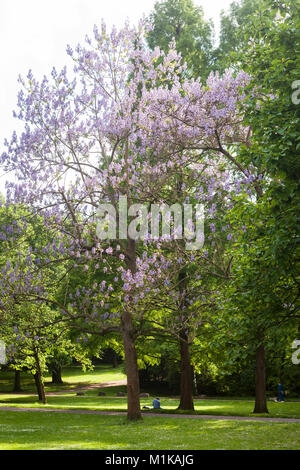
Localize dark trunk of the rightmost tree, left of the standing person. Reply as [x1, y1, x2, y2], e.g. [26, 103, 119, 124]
[253, 344, 269, 413]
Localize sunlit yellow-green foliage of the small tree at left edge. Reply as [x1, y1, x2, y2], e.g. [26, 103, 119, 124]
[0, 205, 90, 382]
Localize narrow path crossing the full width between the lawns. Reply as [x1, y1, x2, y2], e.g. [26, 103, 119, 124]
[0, 406, 300, 423]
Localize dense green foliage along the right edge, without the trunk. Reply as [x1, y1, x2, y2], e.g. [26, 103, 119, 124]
[210, 1, 300, 390]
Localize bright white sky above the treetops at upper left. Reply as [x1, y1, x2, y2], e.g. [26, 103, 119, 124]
[0, 0, 232, 192]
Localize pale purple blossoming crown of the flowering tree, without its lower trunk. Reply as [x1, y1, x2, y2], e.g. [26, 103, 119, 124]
[0, 18, 258, 334]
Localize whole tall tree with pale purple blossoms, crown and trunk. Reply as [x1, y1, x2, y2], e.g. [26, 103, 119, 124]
[2, 20, 252, 419]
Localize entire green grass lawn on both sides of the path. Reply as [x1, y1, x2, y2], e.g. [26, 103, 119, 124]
[0, 366, 300, 450]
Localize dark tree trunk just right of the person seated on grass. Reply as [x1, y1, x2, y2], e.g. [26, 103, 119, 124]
[178, 333, 194, 410]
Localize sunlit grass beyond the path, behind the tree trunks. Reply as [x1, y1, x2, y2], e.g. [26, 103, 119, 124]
[0, 365, 300, 418]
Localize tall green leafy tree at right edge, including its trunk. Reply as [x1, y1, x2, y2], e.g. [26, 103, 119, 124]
[212, 1, 299, 412]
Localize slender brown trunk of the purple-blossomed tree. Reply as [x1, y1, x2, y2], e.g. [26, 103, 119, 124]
[122, 239, 142, 420]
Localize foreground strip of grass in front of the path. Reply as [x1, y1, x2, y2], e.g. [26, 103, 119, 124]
[0, 409, 300, 450]
